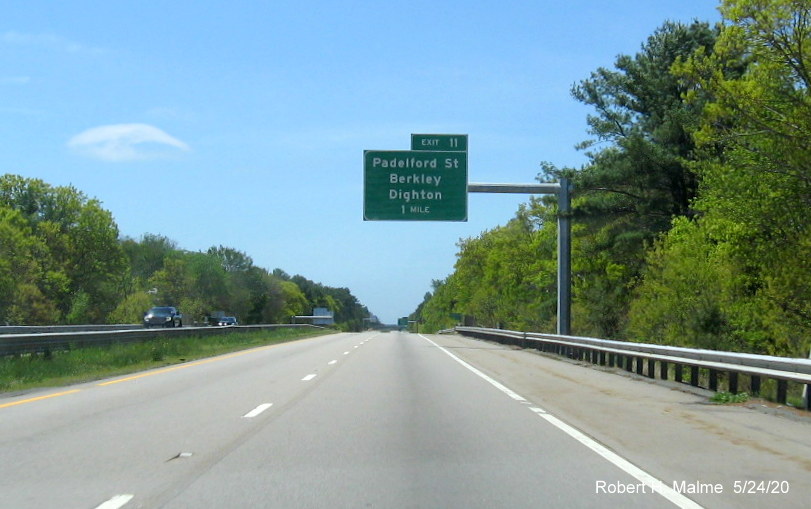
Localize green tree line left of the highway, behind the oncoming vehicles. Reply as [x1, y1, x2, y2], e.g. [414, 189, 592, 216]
[0, 174, 370, 330]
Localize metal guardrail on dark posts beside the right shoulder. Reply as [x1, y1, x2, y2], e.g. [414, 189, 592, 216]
[454, 327, 811, 410]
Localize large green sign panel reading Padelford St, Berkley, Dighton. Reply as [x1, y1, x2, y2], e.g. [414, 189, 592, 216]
[363, 150, 467, 221]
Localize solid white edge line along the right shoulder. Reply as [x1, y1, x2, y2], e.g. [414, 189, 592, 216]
[419, 334, 703, 509]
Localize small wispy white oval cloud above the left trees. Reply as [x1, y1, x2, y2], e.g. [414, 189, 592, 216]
[68, 124, 190, 162]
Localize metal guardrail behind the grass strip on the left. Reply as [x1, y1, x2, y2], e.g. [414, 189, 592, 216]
[0, 324, 323, 357]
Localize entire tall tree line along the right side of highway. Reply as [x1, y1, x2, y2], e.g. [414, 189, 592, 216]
[412, 0, 811, 357]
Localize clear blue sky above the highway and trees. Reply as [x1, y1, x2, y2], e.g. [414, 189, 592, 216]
[0, 0, 719, 323]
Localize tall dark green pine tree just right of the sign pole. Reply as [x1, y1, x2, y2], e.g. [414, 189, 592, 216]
[564, 22, 718, 338]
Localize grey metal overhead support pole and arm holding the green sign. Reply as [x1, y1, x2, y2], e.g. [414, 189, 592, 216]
[467, 178, 572, 336]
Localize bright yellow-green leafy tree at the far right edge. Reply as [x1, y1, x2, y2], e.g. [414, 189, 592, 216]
[656, 0, 811, 356]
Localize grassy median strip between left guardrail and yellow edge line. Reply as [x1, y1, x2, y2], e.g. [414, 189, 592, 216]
[0, 329, 335, 393]
